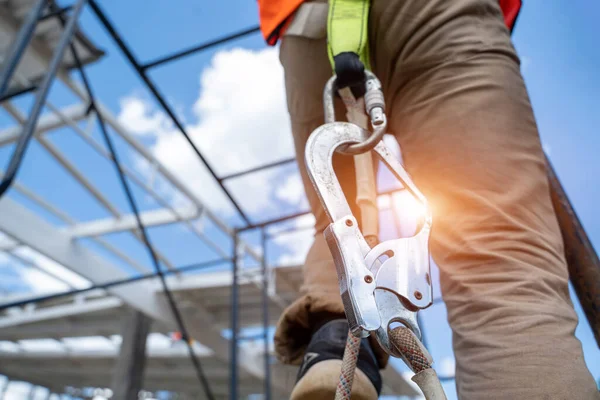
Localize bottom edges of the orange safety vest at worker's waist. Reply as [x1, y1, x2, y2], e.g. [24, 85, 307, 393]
[258, 0, 522, 46]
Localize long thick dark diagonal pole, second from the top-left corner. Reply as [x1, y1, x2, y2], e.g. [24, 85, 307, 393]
[0, 0, 86, 196]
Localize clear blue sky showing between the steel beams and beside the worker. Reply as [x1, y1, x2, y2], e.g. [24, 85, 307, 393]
[0, 0, 600, 398]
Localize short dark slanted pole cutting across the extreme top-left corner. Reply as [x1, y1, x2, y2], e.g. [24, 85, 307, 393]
[0, 0, 47, 95]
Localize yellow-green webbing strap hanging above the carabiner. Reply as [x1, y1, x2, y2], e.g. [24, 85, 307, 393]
[327, 0, 371, 70]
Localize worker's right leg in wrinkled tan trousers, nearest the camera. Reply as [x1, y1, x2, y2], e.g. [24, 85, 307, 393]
[370, 0, 599, 400]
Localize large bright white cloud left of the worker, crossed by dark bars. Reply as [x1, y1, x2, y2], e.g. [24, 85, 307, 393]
[119, 48, 297, 219]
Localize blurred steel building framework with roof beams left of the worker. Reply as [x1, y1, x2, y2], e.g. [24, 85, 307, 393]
[0, 0, 598, 399]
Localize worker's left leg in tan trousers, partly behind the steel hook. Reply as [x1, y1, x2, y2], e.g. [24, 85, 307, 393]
[275, 36, 364, 363]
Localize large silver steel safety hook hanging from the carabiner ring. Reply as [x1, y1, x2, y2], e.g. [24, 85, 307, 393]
[305, 122, 432, 357]
